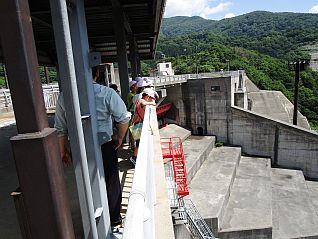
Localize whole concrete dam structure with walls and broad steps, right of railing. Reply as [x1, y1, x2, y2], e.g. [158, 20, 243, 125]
[160, 72, 318, 239]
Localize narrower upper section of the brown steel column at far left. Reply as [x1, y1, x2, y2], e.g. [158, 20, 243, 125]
[0, 0, 48, 133]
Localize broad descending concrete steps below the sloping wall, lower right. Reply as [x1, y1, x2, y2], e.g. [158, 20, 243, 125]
[189, 147, 318, 239]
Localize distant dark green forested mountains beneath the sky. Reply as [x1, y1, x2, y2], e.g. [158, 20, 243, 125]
[159, 11, 318, 60]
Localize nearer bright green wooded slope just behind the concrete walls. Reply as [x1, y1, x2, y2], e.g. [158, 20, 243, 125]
[157, 44, 318, 128]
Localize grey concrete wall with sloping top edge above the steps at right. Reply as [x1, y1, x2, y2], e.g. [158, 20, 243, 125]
[229, 107, 318, 179]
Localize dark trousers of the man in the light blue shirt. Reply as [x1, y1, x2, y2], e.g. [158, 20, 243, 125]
[101, 141, 122, 223]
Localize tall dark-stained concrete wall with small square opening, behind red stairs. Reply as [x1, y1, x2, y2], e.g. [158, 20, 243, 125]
[166, 77, 234, 141]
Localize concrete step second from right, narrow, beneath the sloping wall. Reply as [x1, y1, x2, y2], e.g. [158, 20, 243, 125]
[272, 169, 318, 239]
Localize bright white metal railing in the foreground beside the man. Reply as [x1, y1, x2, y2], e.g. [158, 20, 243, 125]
[123, 106, 156, 239]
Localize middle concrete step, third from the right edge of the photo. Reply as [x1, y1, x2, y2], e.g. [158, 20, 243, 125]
[218, 157, 272, 239]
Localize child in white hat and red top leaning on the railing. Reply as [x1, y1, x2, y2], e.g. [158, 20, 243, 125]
[130, 88, 159, 164]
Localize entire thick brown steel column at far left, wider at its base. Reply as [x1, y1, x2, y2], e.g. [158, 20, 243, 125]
[0, 0, 74, 239]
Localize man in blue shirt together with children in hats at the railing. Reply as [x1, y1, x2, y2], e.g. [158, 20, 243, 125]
[55, 67, 158, 230]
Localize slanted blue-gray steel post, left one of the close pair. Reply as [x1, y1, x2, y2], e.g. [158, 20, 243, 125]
[50, 0, 98, 239]
